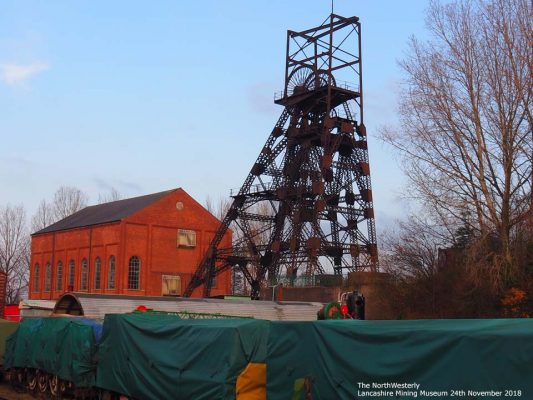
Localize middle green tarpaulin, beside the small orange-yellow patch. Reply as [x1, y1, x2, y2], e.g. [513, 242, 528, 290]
[97, 313, 268, 400]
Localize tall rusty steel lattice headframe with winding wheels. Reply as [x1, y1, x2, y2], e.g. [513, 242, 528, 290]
[185, 14, 378, 298]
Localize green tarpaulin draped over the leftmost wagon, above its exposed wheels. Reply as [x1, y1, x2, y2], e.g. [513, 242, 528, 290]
[4, 317, 96, 387]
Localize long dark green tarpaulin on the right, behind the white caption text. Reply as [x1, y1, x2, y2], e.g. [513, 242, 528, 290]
[267, 319, 533, 400]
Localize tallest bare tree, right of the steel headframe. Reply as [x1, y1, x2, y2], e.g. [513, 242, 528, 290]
[382, 0, 533, 283]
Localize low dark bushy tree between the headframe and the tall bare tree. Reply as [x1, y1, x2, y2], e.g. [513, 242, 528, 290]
[378, 209, 505, 318]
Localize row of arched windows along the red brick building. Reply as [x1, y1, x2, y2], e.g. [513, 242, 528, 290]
[33, 256, 141, 292]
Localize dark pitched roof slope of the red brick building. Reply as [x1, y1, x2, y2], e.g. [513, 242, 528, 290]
[34, 189, 176, 235]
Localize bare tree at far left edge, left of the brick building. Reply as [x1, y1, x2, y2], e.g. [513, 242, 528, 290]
[0, 205, 30, 303]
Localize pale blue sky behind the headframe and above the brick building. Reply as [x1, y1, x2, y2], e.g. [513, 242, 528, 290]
[0, 0, 428, 230]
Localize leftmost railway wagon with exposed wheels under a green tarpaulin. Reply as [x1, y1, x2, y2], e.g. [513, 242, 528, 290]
[4, 317, 102, 398]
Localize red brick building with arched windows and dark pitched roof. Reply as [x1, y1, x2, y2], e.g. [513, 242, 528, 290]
[29, 188, 231, 299]
